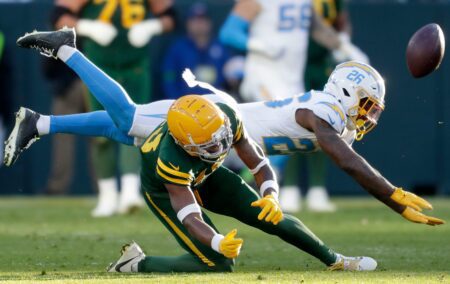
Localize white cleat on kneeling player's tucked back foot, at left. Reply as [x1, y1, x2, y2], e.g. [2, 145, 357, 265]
[106, 242, 145, 272]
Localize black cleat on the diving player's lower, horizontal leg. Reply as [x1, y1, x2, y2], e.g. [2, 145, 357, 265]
[3, 107, 41, 167]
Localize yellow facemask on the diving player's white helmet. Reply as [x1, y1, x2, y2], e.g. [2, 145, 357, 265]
[350, 89, 384, 141]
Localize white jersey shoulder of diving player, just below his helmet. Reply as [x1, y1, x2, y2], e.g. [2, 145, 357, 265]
[308, 91, 347, 133]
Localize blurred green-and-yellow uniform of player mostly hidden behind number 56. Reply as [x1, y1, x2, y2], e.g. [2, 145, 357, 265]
[308, 0, 344, 64]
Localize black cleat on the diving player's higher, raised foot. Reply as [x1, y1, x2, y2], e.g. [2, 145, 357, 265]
[17, 27, 76, 59]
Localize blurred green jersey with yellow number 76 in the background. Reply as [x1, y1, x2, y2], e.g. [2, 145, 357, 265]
[80, 0, 149, 68]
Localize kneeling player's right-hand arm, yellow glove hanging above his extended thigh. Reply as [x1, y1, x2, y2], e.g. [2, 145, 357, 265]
[234, 131, 283, 225]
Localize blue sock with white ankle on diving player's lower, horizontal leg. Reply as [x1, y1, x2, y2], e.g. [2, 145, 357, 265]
[49, 111, 134, 145]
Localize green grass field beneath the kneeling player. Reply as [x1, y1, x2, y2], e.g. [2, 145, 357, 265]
[0, 198, 450, 283]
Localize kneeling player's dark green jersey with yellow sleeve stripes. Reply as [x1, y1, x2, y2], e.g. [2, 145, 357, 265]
[141, 103, 244, 193]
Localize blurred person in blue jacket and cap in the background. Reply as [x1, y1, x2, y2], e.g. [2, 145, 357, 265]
[162, 3, 229, 99]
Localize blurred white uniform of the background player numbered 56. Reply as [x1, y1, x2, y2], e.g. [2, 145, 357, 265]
[241, 0, 312, 102]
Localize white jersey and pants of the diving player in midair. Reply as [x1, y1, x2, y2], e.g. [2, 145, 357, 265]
[129, 91, 355, 155]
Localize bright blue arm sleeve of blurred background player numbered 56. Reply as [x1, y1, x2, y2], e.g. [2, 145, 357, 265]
[219, 14, 249, 51]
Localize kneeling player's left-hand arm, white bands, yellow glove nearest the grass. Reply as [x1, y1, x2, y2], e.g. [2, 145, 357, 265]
[165, 184, 244, 258]
